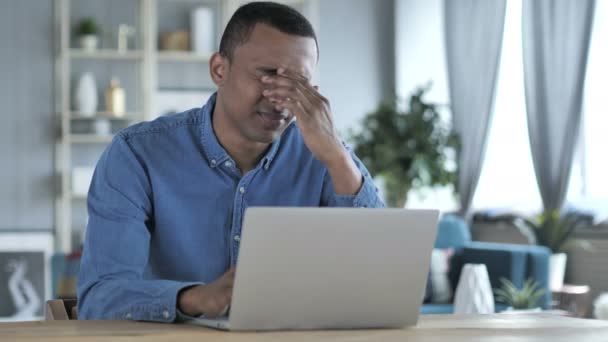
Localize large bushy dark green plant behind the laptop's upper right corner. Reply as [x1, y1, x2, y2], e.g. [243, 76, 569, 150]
[350, 85, 459, 208]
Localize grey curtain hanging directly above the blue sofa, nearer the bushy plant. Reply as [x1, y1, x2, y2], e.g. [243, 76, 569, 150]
[444, 0, 506, 216]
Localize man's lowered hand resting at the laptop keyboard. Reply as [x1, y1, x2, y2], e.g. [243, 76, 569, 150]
[177, 267, 236, 318]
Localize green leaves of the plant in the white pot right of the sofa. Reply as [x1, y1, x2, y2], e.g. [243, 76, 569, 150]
[512, 210, 591, 253]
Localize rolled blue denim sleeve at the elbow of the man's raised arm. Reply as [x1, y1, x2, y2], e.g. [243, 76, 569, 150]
[321, 144, 385, 208]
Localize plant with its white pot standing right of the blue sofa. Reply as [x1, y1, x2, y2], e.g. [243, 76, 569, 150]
[512, 210, 592, 290]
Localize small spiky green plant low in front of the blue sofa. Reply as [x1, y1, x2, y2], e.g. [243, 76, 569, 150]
[494, 278, 545, 309]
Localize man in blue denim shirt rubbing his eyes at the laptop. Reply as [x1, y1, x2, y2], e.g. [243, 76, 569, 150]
[78, 2, 383, 322]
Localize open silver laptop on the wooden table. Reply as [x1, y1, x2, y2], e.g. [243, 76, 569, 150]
[187, 207, 439, 331]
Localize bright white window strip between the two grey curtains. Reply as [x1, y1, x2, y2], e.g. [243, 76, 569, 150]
[473, 0, 541, 211]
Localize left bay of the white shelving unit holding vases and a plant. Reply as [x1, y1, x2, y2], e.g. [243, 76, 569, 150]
[55, 0, 155, 253]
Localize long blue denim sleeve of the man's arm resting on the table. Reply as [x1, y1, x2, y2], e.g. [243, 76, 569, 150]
[77, 135, 198, 322]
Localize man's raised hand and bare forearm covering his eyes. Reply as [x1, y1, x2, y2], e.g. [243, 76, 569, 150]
[261, 68, 362, 195]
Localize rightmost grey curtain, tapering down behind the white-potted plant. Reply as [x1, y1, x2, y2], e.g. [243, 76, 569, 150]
[522, 0, 595, 210]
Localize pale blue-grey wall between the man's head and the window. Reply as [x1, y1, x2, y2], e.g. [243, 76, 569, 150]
[319, 0, 395, 132]
